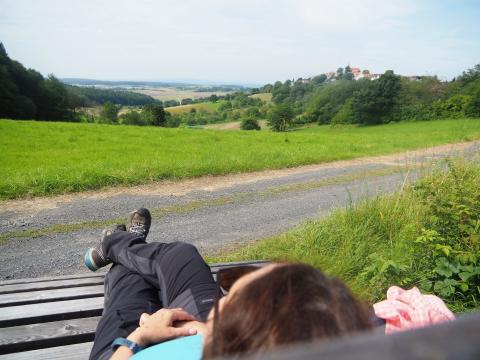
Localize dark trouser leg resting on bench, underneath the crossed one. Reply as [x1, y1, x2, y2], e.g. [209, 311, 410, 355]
[90, 264, 161, 360]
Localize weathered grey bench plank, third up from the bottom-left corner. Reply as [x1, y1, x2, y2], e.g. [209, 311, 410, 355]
[0, 297, 103, 327]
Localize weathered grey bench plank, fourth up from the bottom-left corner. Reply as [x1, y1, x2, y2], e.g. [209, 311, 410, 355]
[0, 285, 104, 307]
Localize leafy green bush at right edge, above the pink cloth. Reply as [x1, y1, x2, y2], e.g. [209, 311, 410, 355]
[415, 163, 480, 308]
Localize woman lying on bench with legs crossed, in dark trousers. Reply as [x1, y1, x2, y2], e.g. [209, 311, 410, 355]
[84, 208, 452, 360]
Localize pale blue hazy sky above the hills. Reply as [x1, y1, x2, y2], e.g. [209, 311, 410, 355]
[0, 0, 480, 84]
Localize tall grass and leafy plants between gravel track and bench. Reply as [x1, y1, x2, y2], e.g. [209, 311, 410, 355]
[213, 161, 480, 312]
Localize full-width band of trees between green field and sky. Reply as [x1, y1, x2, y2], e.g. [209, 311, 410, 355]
[0, 39, 480, 131]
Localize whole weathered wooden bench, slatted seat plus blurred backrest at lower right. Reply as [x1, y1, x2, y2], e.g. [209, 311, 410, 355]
[4, 261, 480, 360]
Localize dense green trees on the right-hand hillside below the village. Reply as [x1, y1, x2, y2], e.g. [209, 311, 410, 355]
[258, 64, 480, 131]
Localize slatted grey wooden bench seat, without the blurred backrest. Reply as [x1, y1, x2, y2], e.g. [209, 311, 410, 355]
[0, 261, 267, 360]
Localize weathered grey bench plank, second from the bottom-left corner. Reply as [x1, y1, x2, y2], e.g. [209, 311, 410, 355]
[0, 317, 100, 354]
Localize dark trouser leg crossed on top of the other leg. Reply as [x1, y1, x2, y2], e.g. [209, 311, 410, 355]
[103, 231, 217, 321]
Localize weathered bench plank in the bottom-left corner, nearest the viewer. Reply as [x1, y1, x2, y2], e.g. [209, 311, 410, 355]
[0, 342, 93, 360]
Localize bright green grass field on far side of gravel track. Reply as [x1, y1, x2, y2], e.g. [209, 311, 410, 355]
[0, 119, 480, 199]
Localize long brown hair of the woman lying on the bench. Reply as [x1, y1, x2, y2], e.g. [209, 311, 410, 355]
[203, 264, 372, 359]
